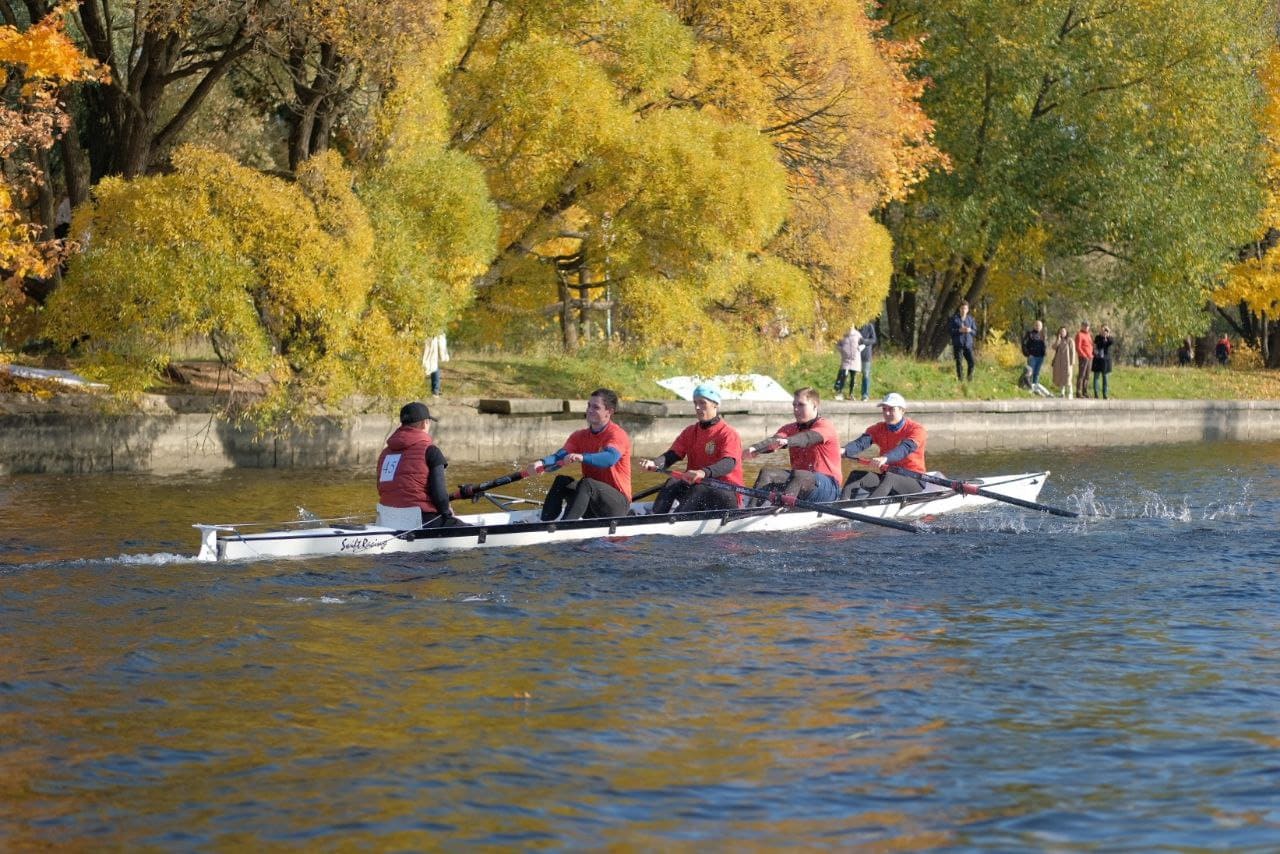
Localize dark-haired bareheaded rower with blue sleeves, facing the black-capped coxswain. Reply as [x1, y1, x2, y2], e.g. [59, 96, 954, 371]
[525, 388, 631, 522]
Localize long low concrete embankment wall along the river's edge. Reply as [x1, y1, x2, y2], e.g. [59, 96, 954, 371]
[0, 396, 1280, 474]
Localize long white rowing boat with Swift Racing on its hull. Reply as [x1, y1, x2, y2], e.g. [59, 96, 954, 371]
[195, 471, 1050, 562]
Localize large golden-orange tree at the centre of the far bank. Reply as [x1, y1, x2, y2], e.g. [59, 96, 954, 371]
[445, 0, 937, 367]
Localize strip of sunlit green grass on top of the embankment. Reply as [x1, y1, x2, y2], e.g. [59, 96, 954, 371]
[443, 350, 1280, 401]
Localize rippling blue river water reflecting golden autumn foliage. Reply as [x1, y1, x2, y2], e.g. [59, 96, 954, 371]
[0, 444, 1280, 850]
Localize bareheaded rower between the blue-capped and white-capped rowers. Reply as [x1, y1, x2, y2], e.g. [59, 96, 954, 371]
[746, 385, 841, 502]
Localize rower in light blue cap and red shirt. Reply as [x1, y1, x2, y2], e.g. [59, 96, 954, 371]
[640, 384, 745, 513]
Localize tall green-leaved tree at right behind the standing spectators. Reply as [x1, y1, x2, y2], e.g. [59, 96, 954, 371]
[881, 0, 1274, 356]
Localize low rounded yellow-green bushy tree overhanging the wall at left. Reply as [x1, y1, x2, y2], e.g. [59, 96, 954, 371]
[46, 147, 416, 416]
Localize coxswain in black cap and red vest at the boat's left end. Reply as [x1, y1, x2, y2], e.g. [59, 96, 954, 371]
[378, 401, 466, 528]
